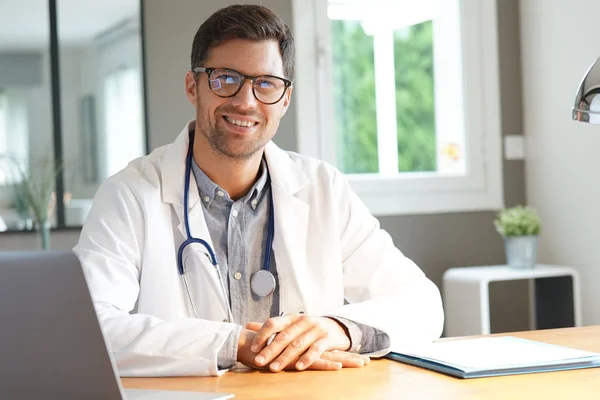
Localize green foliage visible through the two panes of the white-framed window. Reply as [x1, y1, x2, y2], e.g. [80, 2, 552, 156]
[331, 20, 437, 173]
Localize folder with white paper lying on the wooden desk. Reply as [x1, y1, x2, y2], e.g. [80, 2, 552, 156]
[387, 336, 600, 378]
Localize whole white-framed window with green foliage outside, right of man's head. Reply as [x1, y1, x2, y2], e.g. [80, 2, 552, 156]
[294, 0, 503, 215]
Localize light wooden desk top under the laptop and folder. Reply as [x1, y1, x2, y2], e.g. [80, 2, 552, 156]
[122, 326, 600, 400]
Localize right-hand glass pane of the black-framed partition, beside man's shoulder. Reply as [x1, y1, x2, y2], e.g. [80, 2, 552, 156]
[57, 0, 146, 226]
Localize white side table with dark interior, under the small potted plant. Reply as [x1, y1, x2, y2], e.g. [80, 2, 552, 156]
[443, 265, 581, 336]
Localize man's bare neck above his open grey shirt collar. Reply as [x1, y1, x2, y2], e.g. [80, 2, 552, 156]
[194, 141, 262, 200]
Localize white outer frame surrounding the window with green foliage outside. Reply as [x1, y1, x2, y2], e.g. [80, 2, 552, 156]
[292, 0, 504, 216]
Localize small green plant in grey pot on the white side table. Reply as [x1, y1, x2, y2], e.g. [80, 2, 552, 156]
[494, 205, 541, 268]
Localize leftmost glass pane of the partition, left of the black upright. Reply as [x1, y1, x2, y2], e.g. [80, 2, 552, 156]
[0, 0, 56, 231]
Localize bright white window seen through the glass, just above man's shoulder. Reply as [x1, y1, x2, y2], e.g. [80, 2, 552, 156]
[104, 68, 145, 178]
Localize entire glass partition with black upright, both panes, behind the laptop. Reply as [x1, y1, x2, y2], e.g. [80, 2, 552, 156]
[0, 0, 147, 232]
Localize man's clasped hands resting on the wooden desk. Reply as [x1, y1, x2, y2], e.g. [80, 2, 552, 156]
[238, 314, 370, 372]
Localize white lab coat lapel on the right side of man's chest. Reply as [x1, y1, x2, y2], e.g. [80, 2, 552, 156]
[265, 142, 314, 314]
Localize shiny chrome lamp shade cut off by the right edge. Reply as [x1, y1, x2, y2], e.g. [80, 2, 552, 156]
[573, 58, 600, 124]
